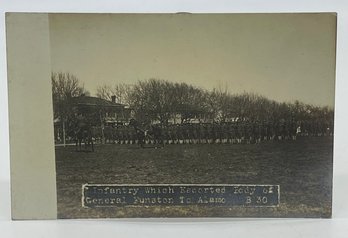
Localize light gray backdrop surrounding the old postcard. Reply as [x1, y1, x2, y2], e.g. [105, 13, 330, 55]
[0, 0, 348, 238]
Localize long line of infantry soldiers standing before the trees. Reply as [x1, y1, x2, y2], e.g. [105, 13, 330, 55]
[93, 121, 333, 144]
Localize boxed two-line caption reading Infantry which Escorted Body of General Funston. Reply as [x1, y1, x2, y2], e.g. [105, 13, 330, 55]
[82, 184, 280, 208]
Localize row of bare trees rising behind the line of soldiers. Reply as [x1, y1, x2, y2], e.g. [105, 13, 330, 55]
[97, 79, 334, 123]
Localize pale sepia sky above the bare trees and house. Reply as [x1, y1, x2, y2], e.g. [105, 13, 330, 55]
[49, 14, 336, 106]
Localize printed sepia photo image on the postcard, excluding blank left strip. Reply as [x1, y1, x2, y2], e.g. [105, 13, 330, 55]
[49, 13, 336, 218]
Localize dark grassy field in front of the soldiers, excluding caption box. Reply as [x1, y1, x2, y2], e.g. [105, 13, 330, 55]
[56, 137, 333, 218]
